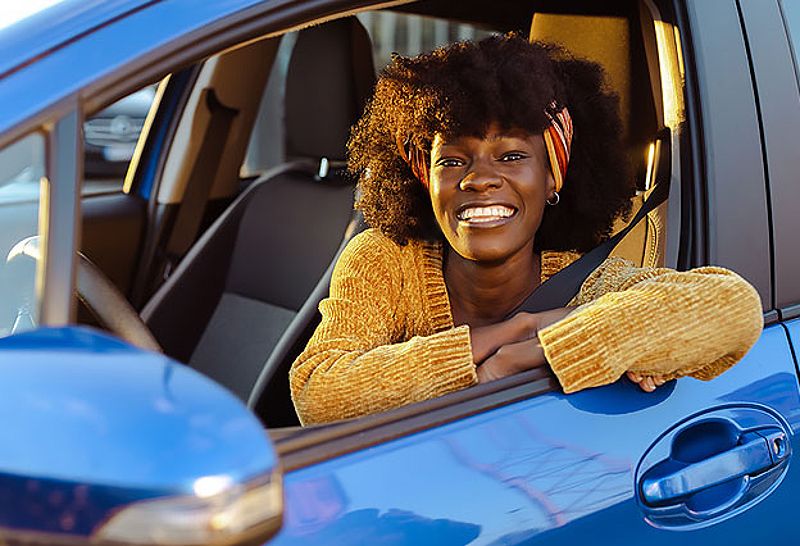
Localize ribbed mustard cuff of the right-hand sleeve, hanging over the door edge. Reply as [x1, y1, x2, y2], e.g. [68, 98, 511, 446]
[537, 304, 625, 393]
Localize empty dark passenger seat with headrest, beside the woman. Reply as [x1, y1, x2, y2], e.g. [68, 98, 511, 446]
[142, 17, 375, 400]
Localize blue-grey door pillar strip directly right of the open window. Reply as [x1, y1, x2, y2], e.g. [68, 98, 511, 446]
[684, 0, 773, 310]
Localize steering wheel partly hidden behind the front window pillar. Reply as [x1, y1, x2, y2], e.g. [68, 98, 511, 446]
[6, 235, 163, 352]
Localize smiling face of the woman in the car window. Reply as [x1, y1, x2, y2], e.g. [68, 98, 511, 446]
[430, 125, 554, 263]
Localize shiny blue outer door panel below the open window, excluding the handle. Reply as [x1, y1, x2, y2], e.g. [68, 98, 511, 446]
[271, 326, 800, 546]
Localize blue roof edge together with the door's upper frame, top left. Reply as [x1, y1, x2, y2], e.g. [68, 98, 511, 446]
[0, 0, 276, 147]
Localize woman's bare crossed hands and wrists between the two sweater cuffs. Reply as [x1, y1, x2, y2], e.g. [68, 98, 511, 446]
[470, 307, 572, 383]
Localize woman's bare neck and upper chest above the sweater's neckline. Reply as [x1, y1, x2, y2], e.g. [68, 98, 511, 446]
[443, 243, 541, 327]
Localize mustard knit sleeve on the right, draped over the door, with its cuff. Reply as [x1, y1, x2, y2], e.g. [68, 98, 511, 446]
[538, 258, 763, 393]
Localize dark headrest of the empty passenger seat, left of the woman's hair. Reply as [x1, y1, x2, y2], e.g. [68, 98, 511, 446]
[285, 17, 375, 161]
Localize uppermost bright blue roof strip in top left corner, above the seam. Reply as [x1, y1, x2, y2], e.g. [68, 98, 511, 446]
[0, 0, 162, 79]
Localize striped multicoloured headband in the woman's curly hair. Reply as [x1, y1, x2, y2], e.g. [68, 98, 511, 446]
[397, 101, 573, 191]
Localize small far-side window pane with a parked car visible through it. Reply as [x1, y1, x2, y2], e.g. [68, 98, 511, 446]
[83, 85, 156, 195]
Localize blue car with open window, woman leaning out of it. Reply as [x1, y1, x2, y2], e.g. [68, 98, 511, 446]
[0, 0, 800, 546]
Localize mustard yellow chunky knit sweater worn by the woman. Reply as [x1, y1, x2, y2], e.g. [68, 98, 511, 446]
[290, 229, 762, 424]
